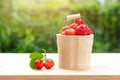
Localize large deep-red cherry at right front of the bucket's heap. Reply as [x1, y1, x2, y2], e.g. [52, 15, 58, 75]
[76, 24, 88, 35]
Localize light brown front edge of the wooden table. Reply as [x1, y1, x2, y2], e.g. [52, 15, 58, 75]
[0, 75, 120, 80]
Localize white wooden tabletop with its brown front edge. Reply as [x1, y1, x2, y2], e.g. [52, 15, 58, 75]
[0, 53, 120, 80]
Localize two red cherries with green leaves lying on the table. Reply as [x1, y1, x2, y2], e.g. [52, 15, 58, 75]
[29, 49, 54, 70]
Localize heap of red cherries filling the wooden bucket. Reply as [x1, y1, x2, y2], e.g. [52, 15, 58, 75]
[62, 18, 92, 35]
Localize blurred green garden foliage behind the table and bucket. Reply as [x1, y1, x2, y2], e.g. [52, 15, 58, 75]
[0, 0, 120, 53]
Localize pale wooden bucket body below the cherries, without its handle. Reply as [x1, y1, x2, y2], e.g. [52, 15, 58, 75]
[57, 34, 94, 70]
